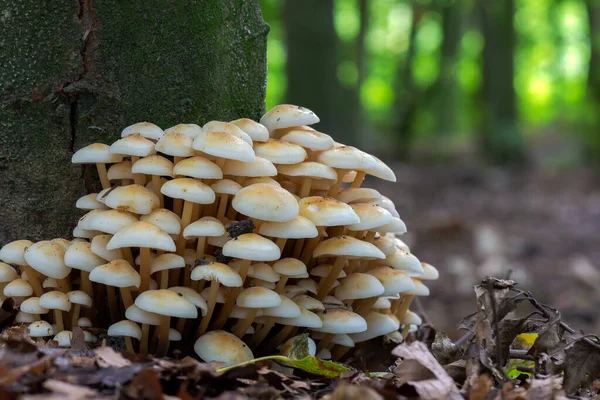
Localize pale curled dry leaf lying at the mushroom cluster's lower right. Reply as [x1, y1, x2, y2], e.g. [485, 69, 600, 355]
[392, 342, 462, 400]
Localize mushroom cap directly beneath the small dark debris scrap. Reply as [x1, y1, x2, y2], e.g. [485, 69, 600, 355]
[223, 233, 281, 261]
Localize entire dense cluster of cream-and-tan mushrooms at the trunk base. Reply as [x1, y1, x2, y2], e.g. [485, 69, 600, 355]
[0, 105, 438, 365]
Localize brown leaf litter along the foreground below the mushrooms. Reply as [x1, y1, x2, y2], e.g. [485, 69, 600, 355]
[0, 277, 600, 400]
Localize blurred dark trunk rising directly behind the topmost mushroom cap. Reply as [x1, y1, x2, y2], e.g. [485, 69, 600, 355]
[283, 0, 345, 137]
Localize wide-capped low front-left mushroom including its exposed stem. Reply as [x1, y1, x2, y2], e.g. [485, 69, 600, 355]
[135, 289, 198, 357]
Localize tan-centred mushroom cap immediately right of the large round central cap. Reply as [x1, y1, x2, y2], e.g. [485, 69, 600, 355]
[298, 196, 360, 226]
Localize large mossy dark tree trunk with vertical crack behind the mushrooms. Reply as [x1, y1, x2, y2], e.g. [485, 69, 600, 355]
[0, 0, 268, 243]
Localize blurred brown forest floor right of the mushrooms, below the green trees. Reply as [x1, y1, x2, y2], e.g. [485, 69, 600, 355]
[366, 164, 600, 339]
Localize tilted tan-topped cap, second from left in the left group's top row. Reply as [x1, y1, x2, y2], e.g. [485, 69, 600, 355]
[25, 240, 71, 279]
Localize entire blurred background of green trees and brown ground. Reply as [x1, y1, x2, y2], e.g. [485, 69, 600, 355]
[261, 0, 600, 336]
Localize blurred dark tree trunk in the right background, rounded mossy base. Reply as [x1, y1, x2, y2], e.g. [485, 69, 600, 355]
[479, 0, 525, 164]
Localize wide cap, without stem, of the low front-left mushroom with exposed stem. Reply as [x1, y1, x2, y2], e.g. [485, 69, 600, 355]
[135, 289, 198, 318]
